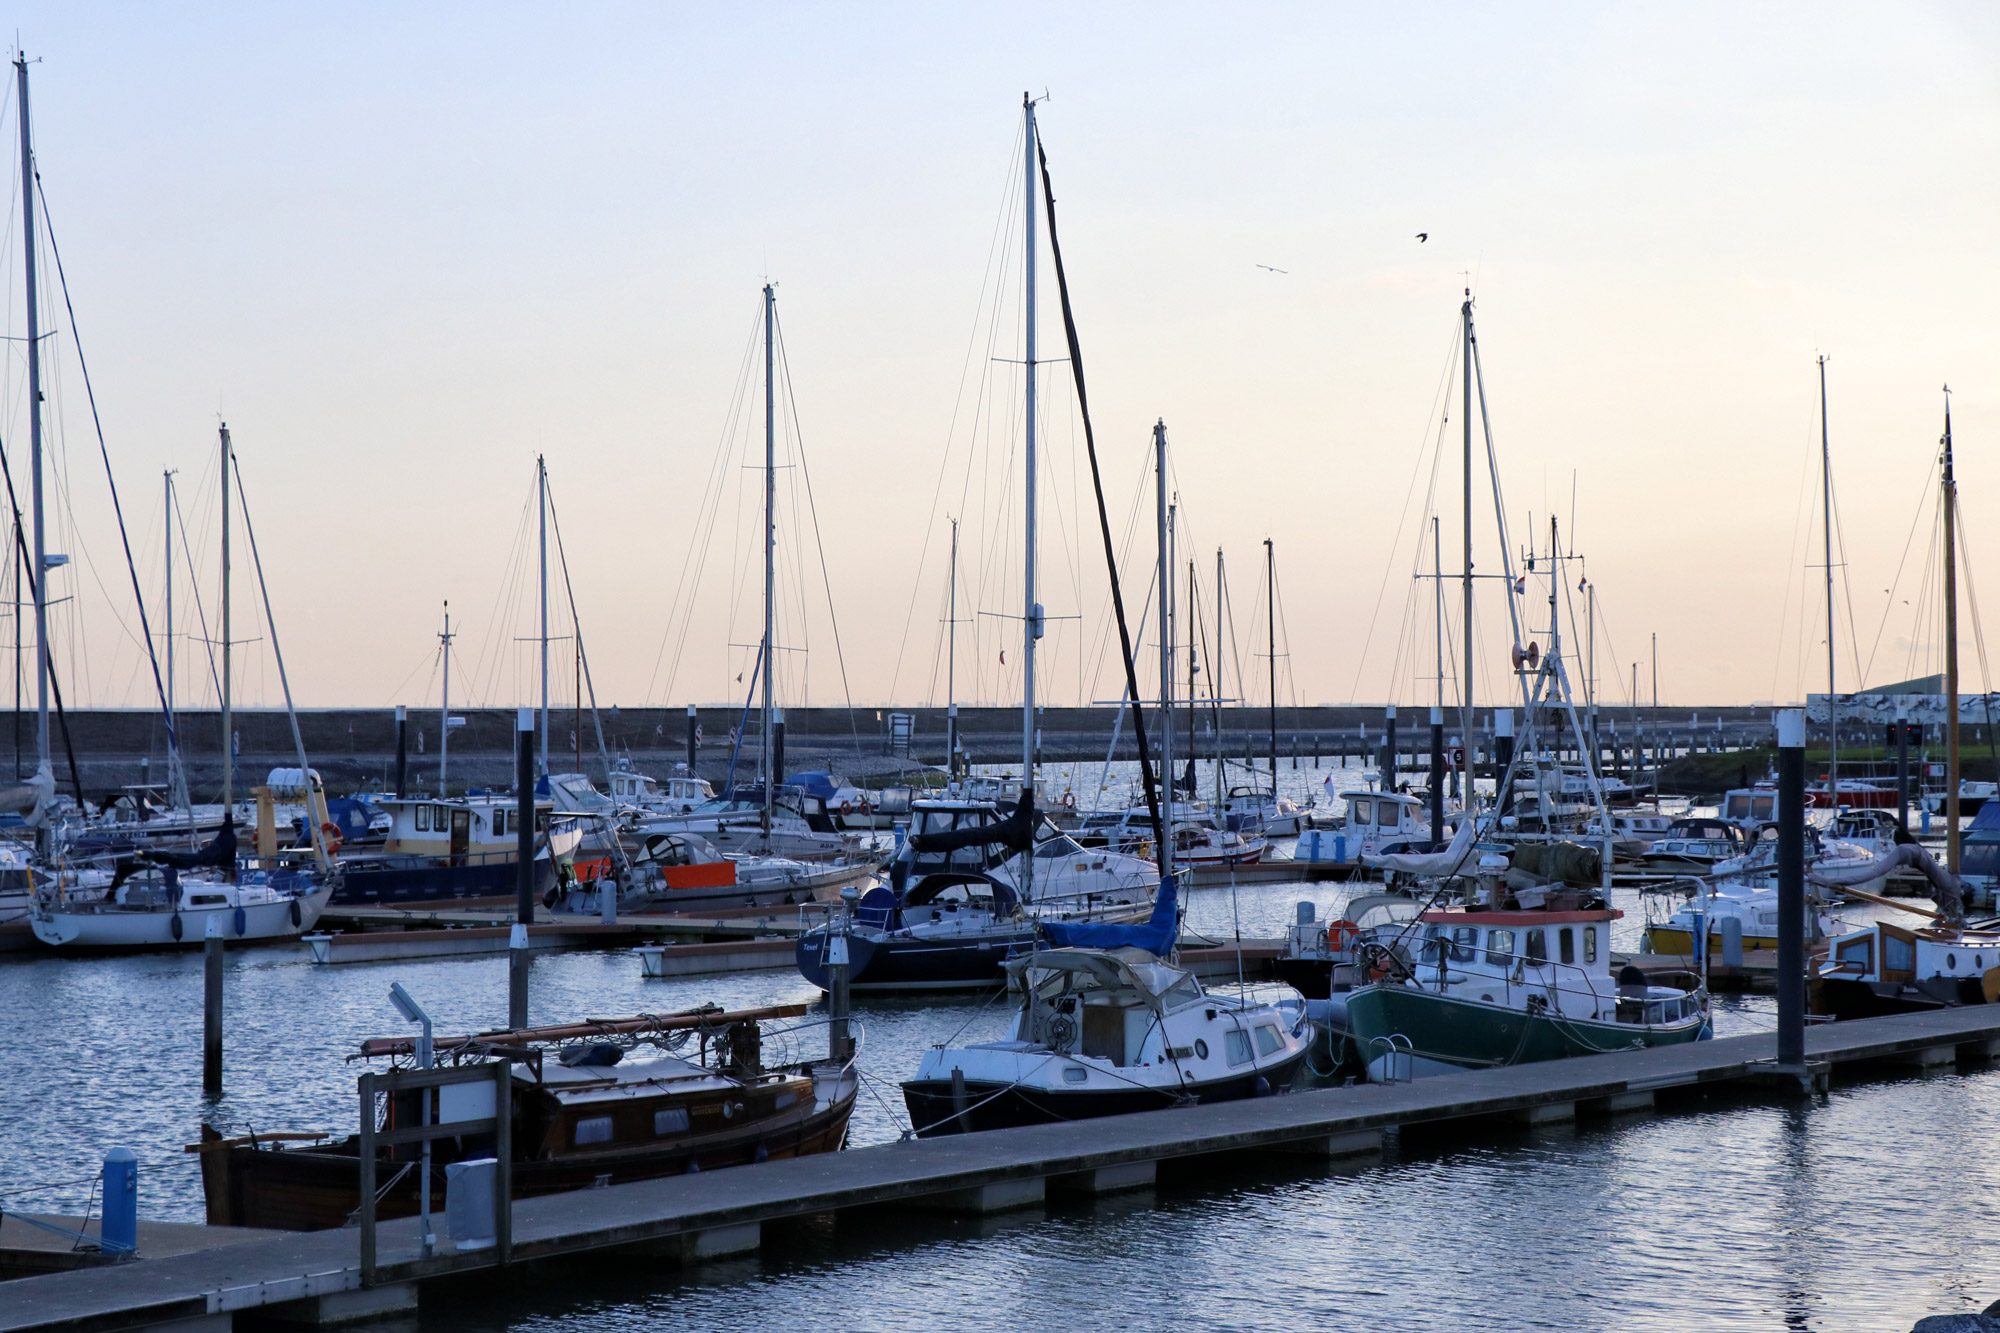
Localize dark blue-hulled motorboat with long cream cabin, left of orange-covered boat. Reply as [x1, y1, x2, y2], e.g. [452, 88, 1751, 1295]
[334, 789, 584, 907]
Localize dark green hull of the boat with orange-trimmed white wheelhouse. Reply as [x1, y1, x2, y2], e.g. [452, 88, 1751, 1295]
[1346, 985, 1708, 1069]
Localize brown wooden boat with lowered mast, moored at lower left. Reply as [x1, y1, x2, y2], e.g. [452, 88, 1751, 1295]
[186, 1005, 860, 1231]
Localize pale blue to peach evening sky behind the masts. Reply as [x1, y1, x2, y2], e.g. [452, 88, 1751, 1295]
[0, 4, 2000, 709]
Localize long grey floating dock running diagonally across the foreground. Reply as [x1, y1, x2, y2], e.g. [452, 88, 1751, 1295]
[0, 1005, 2000, 1333]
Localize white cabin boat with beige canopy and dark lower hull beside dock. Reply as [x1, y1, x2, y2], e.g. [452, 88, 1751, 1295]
[902, 947, 1312, 1139]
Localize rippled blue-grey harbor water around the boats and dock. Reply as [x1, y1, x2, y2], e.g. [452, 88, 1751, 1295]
[0, 752, 1976, 1333]
